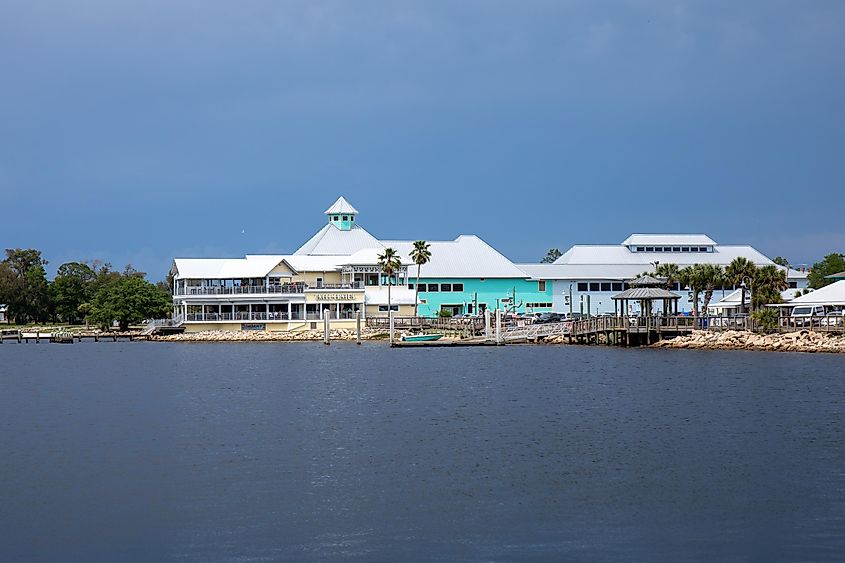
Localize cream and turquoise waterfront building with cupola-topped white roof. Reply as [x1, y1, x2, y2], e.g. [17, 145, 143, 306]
[171, 197, 552, 330]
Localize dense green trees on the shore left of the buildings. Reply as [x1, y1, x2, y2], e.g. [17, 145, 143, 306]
[0, 248, 172, 330]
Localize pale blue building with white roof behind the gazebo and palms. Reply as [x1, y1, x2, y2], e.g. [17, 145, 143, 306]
[518, 234, 807, 314]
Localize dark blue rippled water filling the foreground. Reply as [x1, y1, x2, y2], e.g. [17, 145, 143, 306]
[0, 343, 845, 561]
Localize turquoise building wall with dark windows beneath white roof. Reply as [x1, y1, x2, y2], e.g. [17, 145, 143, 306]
[408, 276, 553, 317]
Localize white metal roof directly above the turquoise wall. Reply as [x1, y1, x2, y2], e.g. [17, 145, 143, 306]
[382, 235, 528, 279]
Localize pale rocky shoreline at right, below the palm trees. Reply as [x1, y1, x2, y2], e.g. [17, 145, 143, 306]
[651, 330, 845, 353]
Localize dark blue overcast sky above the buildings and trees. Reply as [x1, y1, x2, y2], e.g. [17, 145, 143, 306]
[0, 0, 845, 281]
